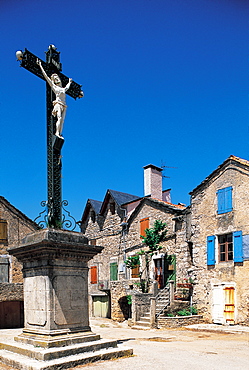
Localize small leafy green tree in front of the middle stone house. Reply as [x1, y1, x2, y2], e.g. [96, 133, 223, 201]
[125, 220, 167, 293]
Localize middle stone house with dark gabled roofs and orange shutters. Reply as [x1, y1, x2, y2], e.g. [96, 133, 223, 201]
[81, 165, 191, 321]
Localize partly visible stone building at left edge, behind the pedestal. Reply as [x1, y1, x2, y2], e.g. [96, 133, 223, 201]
[0, 196, 37, 328]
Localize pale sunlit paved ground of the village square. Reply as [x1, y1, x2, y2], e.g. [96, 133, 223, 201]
[0, 319, 249, 370]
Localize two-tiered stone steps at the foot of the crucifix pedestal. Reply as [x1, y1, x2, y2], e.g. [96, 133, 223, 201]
[0, 332, 133, 370]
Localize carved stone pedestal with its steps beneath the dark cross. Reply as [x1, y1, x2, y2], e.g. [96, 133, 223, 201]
[0, 229, 132, 369]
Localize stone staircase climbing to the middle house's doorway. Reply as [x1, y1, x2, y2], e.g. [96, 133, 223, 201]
[132, 285, 170, 330]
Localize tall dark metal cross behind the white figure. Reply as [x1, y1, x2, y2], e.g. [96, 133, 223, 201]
[16, 45, 84, 229]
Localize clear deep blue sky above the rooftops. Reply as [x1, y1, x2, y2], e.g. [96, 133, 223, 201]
[0, 0, 249, 227]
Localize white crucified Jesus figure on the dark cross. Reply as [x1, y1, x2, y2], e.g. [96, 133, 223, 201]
[37, 59, 72, 138]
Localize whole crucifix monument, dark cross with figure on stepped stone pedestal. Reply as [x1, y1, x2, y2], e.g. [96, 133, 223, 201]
[0, 45, 132, 370]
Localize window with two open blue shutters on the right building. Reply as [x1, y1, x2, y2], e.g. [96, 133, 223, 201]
[207, 231, 244, 266]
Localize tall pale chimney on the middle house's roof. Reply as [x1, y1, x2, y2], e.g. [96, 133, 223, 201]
[144, 164, 163, 200]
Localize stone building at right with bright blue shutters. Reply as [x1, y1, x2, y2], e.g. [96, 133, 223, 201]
[188, 156, 249, 325]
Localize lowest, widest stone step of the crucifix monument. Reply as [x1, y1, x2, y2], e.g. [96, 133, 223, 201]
[0, 344, 133, 370]
